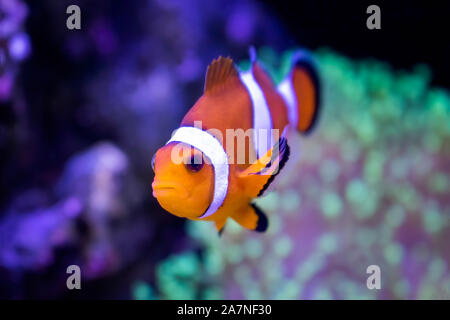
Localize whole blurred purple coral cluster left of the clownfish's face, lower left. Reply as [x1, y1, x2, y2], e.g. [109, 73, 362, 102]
[0, 142, 152, 279]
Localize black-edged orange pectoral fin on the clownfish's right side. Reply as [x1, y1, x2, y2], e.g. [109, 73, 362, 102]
[238, 136, 290, 198]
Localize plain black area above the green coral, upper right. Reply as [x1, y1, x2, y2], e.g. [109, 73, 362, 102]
[264, 0, 450, 87]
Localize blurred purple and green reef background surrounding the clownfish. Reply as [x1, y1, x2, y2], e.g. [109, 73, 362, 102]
[0, 0, 450, 299]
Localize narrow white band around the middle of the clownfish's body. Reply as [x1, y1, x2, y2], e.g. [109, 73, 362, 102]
[239, 67, 273, 159]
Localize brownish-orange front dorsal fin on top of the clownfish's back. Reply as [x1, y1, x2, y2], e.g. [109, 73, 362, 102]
[205, 56, 239, 94]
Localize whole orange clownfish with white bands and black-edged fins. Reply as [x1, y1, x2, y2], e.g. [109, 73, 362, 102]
[152, 49, 320, 234]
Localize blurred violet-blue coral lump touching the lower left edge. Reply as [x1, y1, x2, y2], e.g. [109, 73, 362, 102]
[0, 195, 83, 271]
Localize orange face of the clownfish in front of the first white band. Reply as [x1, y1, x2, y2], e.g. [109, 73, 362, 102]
[152, 142, 214, 219]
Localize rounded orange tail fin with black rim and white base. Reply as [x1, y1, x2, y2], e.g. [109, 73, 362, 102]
[278, 50, 320, 134]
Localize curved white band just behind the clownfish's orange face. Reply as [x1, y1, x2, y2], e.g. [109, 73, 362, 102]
[166, 127, 229, 218]
